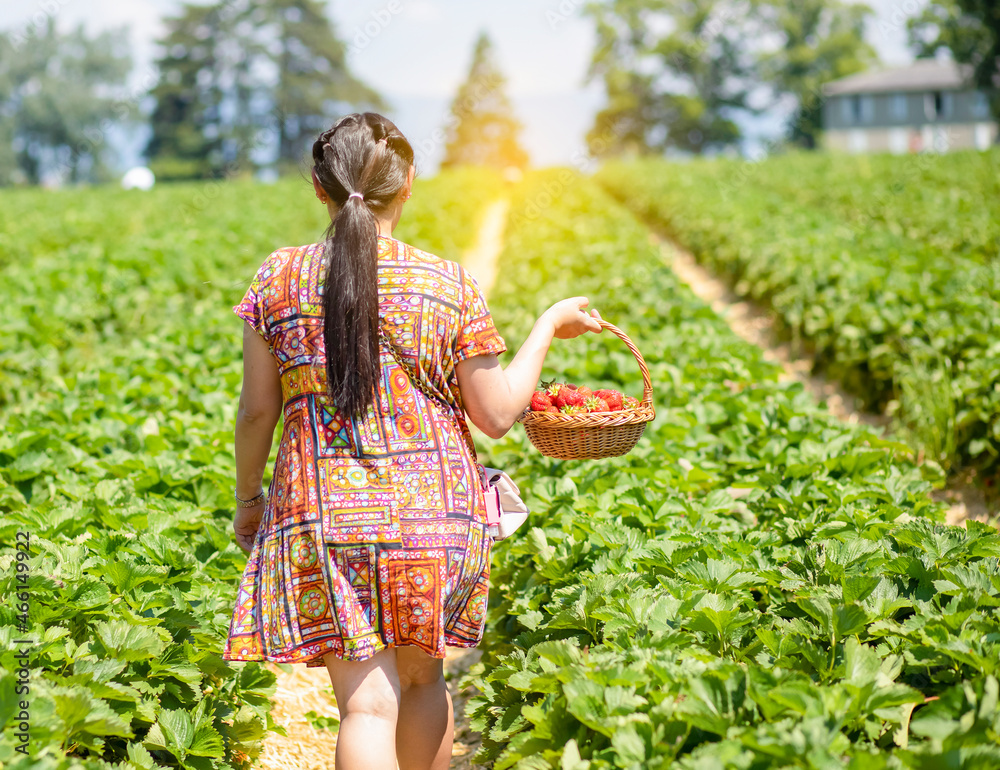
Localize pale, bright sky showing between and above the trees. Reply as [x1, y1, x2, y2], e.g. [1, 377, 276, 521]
[0, 0, 926, 171]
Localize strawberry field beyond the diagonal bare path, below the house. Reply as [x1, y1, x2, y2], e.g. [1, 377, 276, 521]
[600, 151, 1000, 484]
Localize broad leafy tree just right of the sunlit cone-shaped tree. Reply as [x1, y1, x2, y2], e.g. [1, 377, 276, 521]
[586, 0, 758, 155]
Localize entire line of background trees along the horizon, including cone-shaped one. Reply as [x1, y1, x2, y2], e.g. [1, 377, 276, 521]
[0, 0, 1000, 185]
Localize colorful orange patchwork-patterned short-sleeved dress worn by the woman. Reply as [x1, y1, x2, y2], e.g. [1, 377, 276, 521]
[223, 236, 506, 666]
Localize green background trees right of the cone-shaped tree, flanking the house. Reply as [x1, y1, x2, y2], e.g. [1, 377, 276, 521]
[585, 0, 1000, 155]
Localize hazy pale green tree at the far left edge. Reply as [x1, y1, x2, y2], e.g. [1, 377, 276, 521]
[0, 18, 132, 184]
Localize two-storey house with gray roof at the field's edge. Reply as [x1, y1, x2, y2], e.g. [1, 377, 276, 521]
[823, 59, 1000, 154]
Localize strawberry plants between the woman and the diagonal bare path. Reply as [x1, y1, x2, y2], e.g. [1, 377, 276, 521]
[470, 172, 1000, 770]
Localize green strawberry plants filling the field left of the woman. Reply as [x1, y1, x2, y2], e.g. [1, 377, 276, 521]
[0, 166, 488, 770]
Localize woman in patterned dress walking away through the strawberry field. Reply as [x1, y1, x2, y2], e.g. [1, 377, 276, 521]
[224, 113, 601, 770]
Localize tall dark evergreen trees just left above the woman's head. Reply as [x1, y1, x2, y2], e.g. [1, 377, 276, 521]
[147, 0, 384, 177]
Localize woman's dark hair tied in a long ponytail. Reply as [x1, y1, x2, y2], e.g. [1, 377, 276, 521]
[313, 112, 413, 416]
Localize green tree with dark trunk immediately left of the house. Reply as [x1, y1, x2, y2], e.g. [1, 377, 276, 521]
[761, 0, 876, 149]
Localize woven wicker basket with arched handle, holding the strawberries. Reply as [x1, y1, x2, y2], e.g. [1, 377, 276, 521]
[520, 320, 656, 460]
